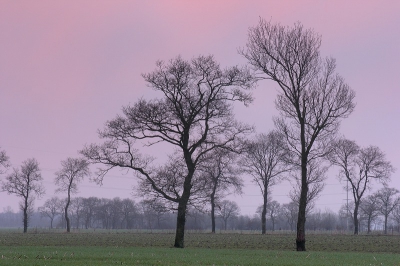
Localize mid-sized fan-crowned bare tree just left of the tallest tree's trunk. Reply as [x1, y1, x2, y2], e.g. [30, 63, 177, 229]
[240, 131, 290, 234]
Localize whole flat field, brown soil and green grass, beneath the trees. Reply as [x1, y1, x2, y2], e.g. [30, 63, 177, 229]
[0, 230, 400, 266]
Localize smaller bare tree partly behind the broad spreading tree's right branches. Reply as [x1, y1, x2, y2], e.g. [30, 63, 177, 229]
[199, 149, 243, 233]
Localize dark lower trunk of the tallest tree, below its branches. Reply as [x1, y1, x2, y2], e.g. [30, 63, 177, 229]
[296, 158, 308, 251]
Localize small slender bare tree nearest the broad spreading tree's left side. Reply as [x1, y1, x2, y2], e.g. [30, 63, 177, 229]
[55, 158, 90, 233]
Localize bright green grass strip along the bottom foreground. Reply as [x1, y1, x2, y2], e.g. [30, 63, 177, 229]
[0, 247, 400, 266]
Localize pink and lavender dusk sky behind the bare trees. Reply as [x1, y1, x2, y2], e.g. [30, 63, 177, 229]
[0, 0, 400, 215]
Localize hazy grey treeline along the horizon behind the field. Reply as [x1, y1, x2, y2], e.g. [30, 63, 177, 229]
[0, 195, 400, 234]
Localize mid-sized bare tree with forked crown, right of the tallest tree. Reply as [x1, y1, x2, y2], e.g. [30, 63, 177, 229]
[329, 138, 394, 235]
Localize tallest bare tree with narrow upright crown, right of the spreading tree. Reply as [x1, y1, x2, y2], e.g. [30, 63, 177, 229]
[240, 19, 355, 251]
